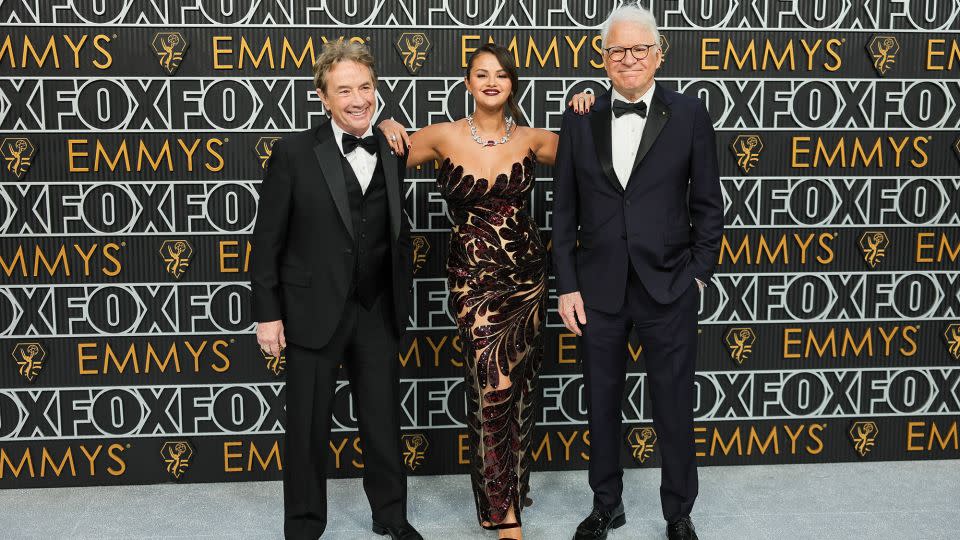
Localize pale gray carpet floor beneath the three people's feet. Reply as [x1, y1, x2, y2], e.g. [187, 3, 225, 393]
[0, 461, 960, 540]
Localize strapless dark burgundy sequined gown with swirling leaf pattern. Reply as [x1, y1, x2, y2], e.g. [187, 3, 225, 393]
[437, 151, 546, 524]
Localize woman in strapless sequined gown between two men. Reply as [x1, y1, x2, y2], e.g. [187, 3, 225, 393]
[379, 44, 592, 538]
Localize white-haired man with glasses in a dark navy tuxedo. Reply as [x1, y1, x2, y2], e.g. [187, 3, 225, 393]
[553, 5, 723, 540]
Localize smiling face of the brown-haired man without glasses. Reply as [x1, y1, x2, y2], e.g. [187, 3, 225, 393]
[317, 60, 377, 137]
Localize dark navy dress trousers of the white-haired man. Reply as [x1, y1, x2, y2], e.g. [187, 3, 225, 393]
[583, 267, 699, 522]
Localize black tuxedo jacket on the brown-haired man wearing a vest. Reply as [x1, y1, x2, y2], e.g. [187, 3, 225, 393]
[250, 120, 412, 348]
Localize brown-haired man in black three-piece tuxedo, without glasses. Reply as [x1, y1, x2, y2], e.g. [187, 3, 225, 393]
[250, 42, 421, 540]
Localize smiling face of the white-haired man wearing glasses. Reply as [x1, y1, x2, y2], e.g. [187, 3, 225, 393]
[603, 21, 663, 99]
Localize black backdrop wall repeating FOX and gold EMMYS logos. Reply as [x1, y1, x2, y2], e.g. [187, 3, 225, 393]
[0, 0, 960, 488]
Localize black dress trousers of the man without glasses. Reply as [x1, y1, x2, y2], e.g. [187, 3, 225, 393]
[283, 291, 407, 540]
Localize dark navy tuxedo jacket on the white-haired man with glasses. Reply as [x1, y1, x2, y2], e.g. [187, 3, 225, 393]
[553, 84, 723, 313]
